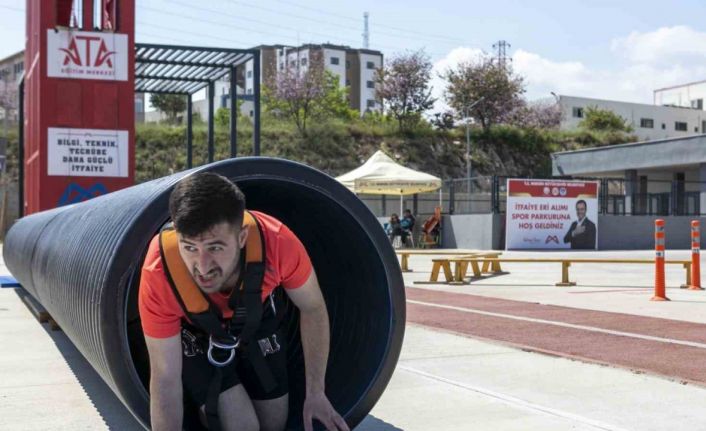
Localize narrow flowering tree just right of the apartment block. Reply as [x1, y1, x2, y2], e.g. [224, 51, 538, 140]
[375, 50, 435, 131]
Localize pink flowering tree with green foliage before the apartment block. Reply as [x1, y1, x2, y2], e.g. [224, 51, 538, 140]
[263, 55, 355, 136]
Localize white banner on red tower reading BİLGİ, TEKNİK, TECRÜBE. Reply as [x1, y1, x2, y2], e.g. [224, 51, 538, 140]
[47, 127, 130, 177]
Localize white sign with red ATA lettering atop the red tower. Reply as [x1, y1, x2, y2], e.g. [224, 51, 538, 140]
[47, 30, 128, 81]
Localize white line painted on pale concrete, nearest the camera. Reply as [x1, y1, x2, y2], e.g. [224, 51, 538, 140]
[397, 365, 626, 431]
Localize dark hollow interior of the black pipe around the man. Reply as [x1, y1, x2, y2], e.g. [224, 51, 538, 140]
[125, 173, 401, 429]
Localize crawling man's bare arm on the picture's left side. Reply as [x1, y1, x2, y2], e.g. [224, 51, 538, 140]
[145, 334, 184, 431]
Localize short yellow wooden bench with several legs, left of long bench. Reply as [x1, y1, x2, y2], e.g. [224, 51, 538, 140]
[415, 251, 503, 284]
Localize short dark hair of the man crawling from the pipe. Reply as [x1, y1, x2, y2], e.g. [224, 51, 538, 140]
[169, 172, 245, 237]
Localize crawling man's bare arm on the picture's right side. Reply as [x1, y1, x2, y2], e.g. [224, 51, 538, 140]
[285, 270, 349, 431]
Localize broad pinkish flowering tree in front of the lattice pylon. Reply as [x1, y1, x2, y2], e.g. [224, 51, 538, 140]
[443, 58, 525, 130]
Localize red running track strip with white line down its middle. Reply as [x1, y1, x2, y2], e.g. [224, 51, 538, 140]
[406, 287, 706, 385]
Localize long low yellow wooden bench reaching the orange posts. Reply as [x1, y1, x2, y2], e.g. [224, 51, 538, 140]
[453, 256, 691, 287]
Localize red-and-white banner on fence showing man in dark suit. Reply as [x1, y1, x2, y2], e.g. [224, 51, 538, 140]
[505, 179, 599, 250]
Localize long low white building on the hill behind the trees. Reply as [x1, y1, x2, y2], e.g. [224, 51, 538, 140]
[558, 95, 706, 141]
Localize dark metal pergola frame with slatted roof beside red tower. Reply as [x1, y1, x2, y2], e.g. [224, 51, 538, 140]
[135, 43, 260, 164]
